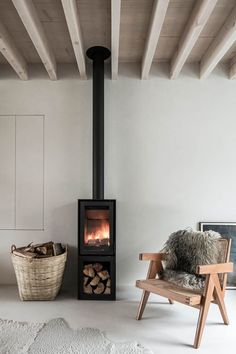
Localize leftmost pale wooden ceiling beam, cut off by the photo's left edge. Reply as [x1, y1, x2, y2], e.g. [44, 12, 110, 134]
[0, 22, 28, 80]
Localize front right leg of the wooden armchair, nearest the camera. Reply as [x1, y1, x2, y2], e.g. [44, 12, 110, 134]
[194, 278, 214, 348]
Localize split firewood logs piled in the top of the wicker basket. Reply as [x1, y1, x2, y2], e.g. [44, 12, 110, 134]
[12, 241, 65, 258]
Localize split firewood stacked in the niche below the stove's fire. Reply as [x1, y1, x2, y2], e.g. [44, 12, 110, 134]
[83, 263, 111, 295]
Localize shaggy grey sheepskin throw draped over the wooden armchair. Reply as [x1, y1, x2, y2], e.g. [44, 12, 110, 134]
[159, 230, 222, 290]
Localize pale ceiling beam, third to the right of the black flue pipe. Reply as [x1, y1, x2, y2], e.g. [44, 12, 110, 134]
[170, 0, 217, 79]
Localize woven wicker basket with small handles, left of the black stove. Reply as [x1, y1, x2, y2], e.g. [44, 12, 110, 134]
[11, 245, 67, 300]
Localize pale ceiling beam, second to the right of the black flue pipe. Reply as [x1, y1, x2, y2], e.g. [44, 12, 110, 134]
[141, 0, 169, 79]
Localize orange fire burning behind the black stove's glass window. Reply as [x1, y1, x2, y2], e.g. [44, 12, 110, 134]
[84, 209, 110, 247]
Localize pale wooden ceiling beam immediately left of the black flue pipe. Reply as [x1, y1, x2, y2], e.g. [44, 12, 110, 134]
[61, 0, 87, 80]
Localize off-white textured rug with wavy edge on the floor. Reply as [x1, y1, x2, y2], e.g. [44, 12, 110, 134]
[0, 318, 152, 354]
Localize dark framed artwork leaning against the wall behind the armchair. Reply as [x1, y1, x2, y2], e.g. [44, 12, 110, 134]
[199, 222, 236, 289]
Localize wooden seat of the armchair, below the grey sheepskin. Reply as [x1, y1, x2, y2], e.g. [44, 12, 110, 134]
[136, 279, 202, 306]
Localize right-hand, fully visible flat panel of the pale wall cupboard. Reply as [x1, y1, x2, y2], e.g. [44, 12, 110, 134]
[16, 116, 44, 229]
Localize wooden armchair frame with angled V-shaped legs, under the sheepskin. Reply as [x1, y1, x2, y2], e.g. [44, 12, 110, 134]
[136, 239, 233, 348]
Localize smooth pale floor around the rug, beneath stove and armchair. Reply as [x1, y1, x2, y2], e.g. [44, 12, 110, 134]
[0, 286, 236, 354]
